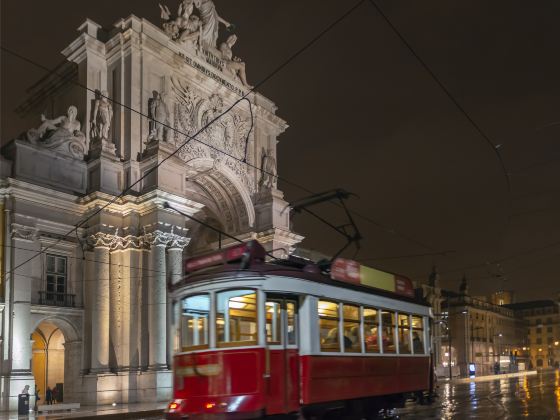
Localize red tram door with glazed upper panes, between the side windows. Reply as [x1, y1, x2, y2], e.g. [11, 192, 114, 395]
[266, 294, 299, 414]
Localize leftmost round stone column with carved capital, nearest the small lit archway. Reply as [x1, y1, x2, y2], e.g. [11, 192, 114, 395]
[88, 232, 114, 373]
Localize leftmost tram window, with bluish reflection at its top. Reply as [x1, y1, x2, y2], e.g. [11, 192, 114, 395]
[181, 294, 210, 351]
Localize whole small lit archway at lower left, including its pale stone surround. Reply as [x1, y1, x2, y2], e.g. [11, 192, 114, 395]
[31, 315, 83, 402]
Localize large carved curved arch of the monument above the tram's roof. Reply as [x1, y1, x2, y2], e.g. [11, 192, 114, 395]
[187, 158, 255, 234]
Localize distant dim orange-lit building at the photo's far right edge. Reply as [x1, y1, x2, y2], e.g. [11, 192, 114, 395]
[505, 300, 560, 368]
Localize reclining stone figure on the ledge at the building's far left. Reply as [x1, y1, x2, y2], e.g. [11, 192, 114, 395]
[24, 105, 88, 160]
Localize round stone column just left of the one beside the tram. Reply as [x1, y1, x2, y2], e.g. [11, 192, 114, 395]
[145, 231, 171, 370]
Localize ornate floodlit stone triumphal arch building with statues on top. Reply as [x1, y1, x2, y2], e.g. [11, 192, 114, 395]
[0, 2, 302, 410]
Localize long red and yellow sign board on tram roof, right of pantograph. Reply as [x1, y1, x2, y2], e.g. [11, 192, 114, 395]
[331, 258, 414, 297]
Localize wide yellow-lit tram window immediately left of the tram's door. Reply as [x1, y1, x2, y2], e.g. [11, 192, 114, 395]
[216, 290, 258, 347]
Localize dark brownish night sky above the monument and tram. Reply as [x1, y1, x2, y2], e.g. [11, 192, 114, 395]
[1, 0, 560, 301]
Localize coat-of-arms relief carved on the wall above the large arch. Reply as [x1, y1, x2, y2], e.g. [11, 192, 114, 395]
[172, 78, 256, 193]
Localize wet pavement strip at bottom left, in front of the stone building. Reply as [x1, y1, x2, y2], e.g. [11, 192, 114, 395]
[0, 403, 167, 420]
